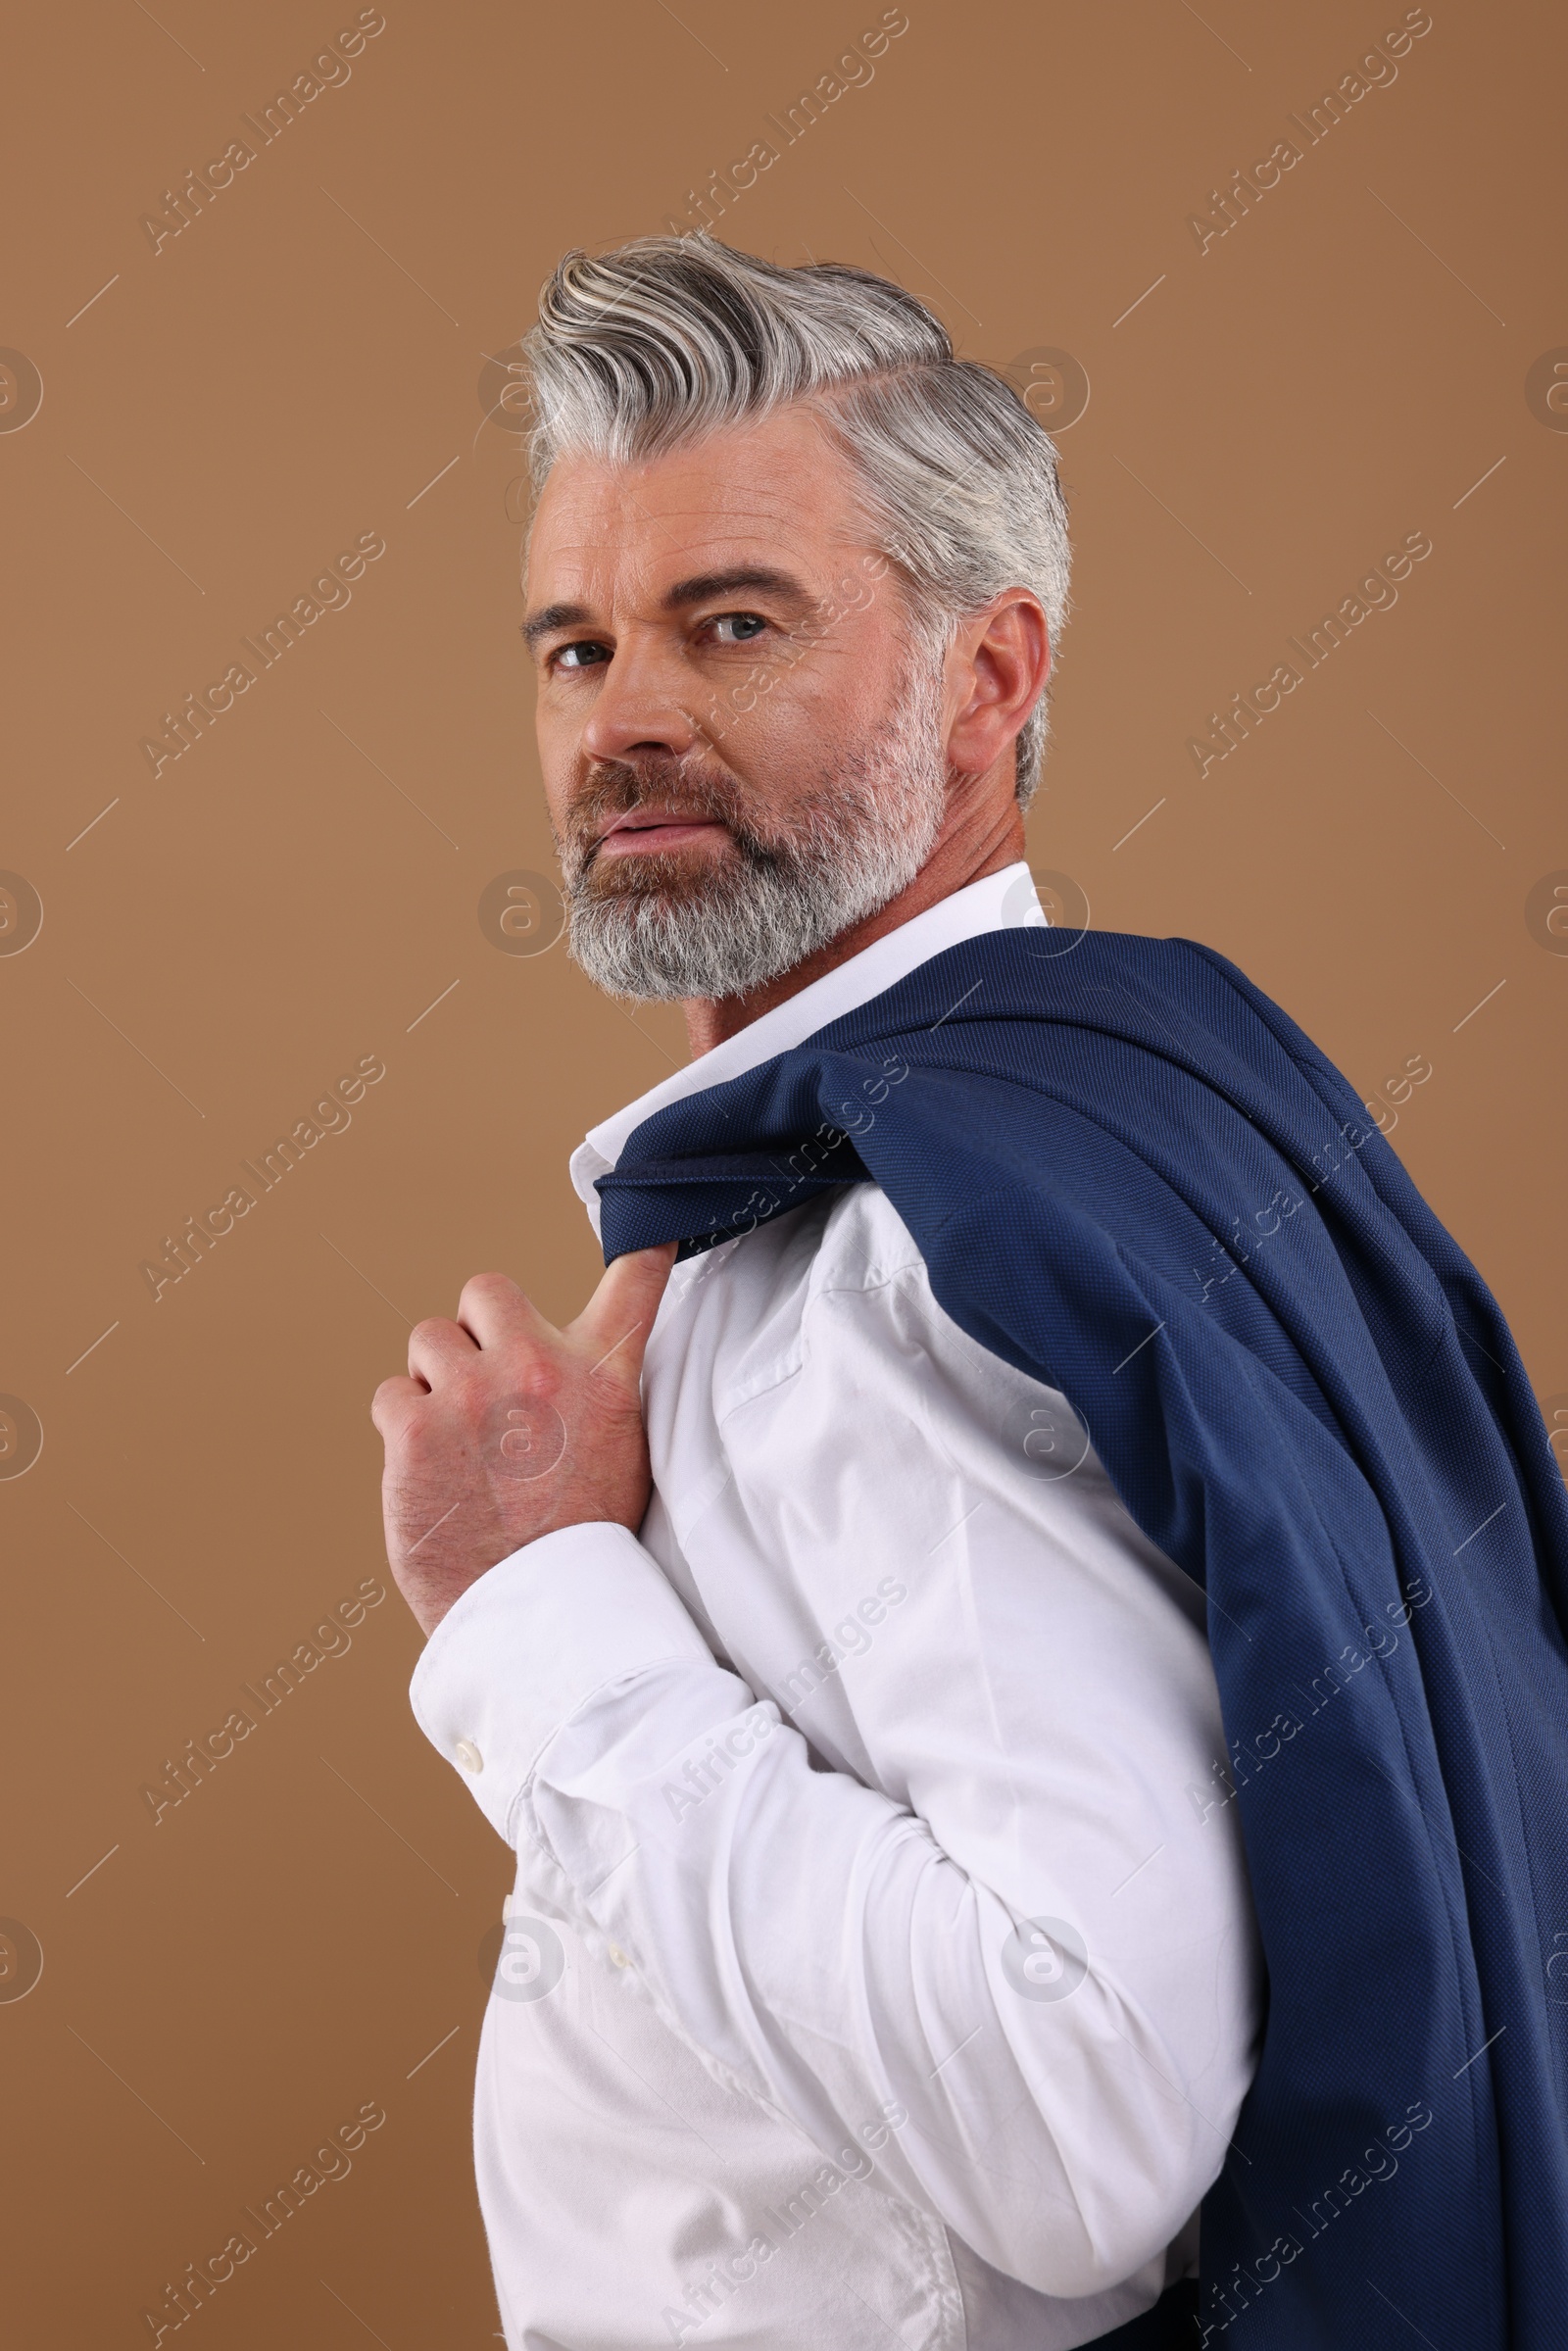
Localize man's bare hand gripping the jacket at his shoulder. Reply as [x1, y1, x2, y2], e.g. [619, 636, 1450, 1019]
[371, 1242, 674, 1634]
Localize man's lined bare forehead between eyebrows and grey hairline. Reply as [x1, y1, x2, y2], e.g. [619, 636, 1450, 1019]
[529, 407, 867, 602]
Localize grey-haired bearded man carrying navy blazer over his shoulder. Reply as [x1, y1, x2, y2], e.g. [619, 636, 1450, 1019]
[373, 237, 1568, 2351]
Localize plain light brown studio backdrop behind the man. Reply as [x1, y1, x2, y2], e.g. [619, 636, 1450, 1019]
[0, 0, 1568, 2351]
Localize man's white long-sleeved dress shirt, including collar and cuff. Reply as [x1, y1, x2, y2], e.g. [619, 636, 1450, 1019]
[412, 865, 1260, 2351]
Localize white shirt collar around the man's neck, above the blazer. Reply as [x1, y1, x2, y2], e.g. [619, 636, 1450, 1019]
[571, 858, 1046, 1232]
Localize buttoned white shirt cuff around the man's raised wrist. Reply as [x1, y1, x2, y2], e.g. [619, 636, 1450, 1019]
[409, 1519, 714, 1845]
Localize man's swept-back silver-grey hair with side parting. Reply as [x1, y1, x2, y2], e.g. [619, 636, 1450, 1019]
[524, 233, 1069, 807]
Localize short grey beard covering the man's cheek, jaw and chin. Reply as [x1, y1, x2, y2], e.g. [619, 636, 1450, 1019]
[562, 663, 948, 1002]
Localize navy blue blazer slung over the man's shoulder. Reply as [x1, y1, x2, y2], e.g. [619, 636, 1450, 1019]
[600, 929, 1568, 2351]
